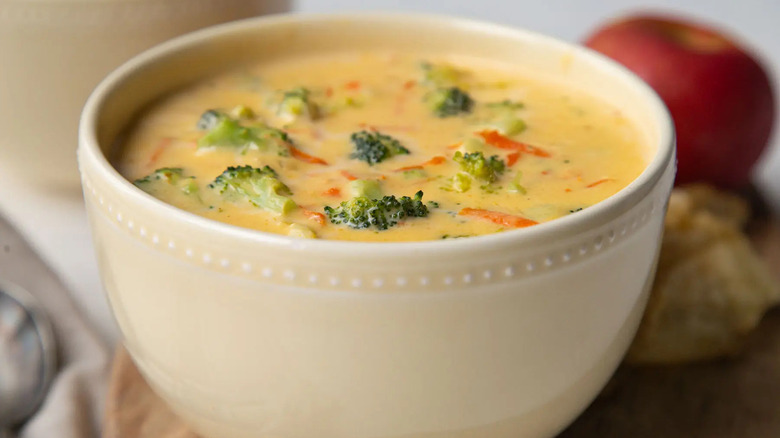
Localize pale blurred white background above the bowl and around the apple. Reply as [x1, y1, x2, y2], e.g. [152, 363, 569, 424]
[296, 0, 780, 207]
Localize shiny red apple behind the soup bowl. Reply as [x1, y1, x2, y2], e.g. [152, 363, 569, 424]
[585, 15, 775, 188]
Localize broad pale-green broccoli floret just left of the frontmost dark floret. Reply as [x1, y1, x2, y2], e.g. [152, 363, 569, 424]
[209, 166, 297, 214]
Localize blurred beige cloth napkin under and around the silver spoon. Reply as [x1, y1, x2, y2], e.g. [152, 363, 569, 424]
[0, 214, 111, 438]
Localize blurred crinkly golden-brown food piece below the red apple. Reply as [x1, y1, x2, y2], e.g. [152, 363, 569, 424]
[627, 185, 780, 364]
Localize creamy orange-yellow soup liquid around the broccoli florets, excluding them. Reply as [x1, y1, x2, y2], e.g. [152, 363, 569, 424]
[116, 53, 646, 241]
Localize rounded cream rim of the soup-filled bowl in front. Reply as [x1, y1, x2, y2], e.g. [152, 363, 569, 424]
[78, 12, 676, 257]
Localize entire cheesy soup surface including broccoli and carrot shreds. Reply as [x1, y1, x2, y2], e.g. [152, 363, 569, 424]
[117, 52, 646, 241]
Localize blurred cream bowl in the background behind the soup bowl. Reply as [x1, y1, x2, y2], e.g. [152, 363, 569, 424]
[0, 0, 290, 190]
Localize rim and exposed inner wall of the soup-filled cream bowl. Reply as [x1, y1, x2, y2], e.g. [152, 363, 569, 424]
[81, 14, 674, 254]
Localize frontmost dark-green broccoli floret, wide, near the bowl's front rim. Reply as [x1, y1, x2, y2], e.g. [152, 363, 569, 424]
[325, 191, 428, 230]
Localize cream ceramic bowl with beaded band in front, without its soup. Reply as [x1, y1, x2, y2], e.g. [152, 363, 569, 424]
[79, 14, 674, 438]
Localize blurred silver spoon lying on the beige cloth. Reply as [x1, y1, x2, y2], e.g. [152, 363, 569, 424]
[0, 281, 57, 438]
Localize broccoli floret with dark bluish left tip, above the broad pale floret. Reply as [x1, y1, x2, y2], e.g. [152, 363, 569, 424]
[198, 110, 292, 156]
